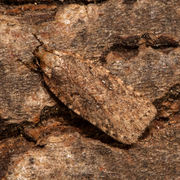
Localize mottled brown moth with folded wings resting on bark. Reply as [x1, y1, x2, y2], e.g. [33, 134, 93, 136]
[35, 46, 157, 144]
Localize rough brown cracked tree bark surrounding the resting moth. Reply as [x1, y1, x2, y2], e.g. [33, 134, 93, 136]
[0, 0, 180, 180]
